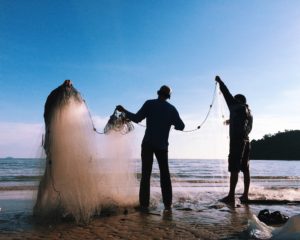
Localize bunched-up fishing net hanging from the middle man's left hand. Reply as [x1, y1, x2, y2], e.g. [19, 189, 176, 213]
[104, 109, 134, 134]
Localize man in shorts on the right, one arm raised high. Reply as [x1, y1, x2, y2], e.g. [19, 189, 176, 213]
[215, 76, 253, 203]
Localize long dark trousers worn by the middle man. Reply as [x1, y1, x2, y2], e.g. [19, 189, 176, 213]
[139, 144, 172, 207]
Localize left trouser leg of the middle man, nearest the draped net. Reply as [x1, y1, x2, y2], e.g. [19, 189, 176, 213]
[139, 146, 153, 209]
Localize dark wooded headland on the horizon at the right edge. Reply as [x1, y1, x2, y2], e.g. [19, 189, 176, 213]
[250, 130, 300, 160]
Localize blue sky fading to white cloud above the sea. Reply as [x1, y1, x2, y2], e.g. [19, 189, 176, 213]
[0, 0, 300, 158]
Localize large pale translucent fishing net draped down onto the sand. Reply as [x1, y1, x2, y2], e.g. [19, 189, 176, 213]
[34, 89, 137, 222]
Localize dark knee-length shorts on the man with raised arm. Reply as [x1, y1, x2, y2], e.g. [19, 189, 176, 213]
[228, 139, 251, 172]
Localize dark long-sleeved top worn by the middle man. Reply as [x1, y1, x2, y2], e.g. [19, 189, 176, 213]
[125, 99, 184, 149]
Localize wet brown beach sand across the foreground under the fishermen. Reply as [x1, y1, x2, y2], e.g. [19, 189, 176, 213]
[0, 192, 299, 240]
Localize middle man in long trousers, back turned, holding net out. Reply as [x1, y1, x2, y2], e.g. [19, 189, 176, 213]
[117, 85, 184, 211]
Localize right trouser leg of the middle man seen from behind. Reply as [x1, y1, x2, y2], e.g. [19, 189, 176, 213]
[155, 150, 172, 210]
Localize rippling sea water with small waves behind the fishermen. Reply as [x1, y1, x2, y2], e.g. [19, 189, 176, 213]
[0, 158, 300, 200]
